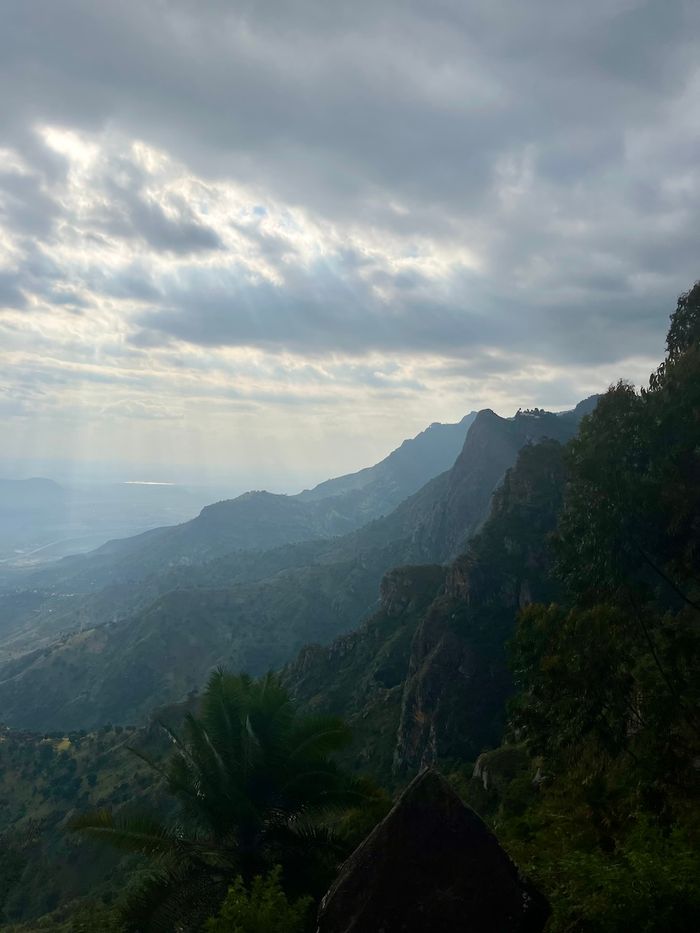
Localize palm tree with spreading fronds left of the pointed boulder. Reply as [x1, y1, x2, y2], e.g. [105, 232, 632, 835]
[71, 670, 362, 933]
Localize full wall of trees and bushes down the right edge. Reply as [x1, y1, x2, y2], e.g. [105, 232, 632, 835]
[487, 284, 700, 933]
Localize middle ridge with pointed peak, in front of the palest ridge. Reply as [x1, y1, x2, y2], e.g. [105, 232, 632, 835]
[0, 398, 592, 729]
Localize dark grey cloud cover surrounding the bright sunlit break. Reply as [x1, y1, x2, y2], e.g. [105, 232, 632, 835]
[0, 0, 700, 363]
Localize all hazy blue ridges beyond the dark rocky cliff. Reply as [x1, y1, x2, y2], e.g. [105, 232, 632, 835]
[0, 403, 590, 730]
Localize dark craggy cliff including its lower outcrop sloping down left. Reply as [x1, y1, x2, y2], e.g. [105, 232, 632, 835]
[288, 441, 565, 780]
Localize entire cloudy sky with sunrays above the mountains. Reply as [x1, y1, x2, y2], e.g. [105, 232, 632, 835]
[0, 0, 700, 488]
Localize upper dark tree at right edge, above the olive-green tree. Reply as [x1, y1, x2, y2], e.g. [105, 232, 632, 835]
[560, 283, 700, 609]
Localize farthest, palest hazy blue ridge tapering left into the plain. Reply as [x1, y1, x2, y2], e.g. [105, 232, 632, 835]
[9, 412, 476, 592]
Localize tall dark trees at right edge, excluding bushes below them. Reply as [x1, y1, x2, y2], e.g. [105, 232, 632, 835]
[514, 284, 700, 789]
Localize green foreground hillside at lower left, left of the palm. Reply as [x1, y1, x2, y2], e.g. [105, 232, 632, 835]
[0, 727, 159, 929]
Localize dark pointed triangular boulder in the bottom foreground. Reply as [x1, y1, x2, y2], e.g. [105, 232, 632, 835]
[318, 769, 549, 933]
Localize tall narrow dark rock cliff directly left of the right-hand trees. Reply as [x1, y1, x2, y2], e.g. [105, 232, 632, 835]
[393, 440, 565, 775]
